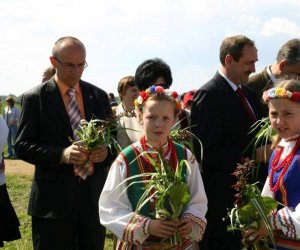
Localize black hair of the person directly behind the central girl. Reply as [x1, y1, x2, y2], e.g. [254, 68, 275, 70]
[134, 58, 173, 91]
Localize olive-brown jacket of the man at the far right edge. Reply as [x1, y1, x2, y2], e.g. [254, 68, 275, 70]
[247, 69, 273, 117]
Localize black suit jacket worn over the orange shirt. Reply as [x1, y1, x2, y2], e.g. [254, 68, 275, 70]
[15, 78, 113, 218]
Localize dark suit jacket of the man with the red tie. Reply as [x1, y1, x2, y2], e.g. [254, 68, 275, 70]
[191, 72, 260, 215]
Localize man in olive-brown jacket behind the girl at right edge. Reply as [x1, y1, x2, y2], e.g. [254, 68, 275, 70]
[248, 39, 300, 117]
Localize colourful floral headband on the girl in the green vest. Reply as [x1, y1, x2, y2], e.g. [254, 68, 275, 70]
[134, 85, 181, 109]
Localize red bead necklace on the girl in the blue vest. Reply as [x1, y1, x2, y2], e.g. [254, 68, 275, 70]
[269, 137, 300, 193]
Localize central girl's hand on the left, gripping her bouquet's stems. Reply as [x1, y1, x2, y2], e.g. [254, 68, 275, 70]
[148, 220, 178, 238]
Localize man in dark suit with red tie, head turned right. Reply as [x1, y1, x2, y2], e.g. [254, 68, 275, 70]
[191, 36, 260, 250]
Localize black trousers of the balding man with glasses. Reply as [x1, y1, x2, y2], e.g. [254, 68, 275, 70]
[32, 214, 105, 250]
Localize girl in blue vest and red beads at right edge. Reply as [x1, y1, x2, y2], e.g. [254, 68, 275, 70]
[245, 80, 300, 250]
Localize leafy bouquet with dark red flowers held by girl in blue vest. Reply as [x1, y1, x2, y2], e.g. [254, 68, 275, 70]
[227, 160, 277, 249]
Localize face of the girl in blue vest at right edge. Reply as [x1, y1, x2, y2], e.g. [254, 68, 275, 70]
[269, 99, 300, 138]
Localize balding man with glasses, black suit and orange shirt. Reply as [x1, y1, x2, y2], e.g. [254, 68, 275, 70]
[16, 37, 113, 250]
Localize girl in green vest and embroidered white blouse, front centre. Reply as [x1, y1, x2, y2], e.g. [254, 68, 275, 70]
[99, 86, 207, 250]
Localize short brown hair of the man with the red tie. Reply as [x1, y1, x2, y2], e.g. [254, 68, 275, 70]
[220, 35, 255, 65]
